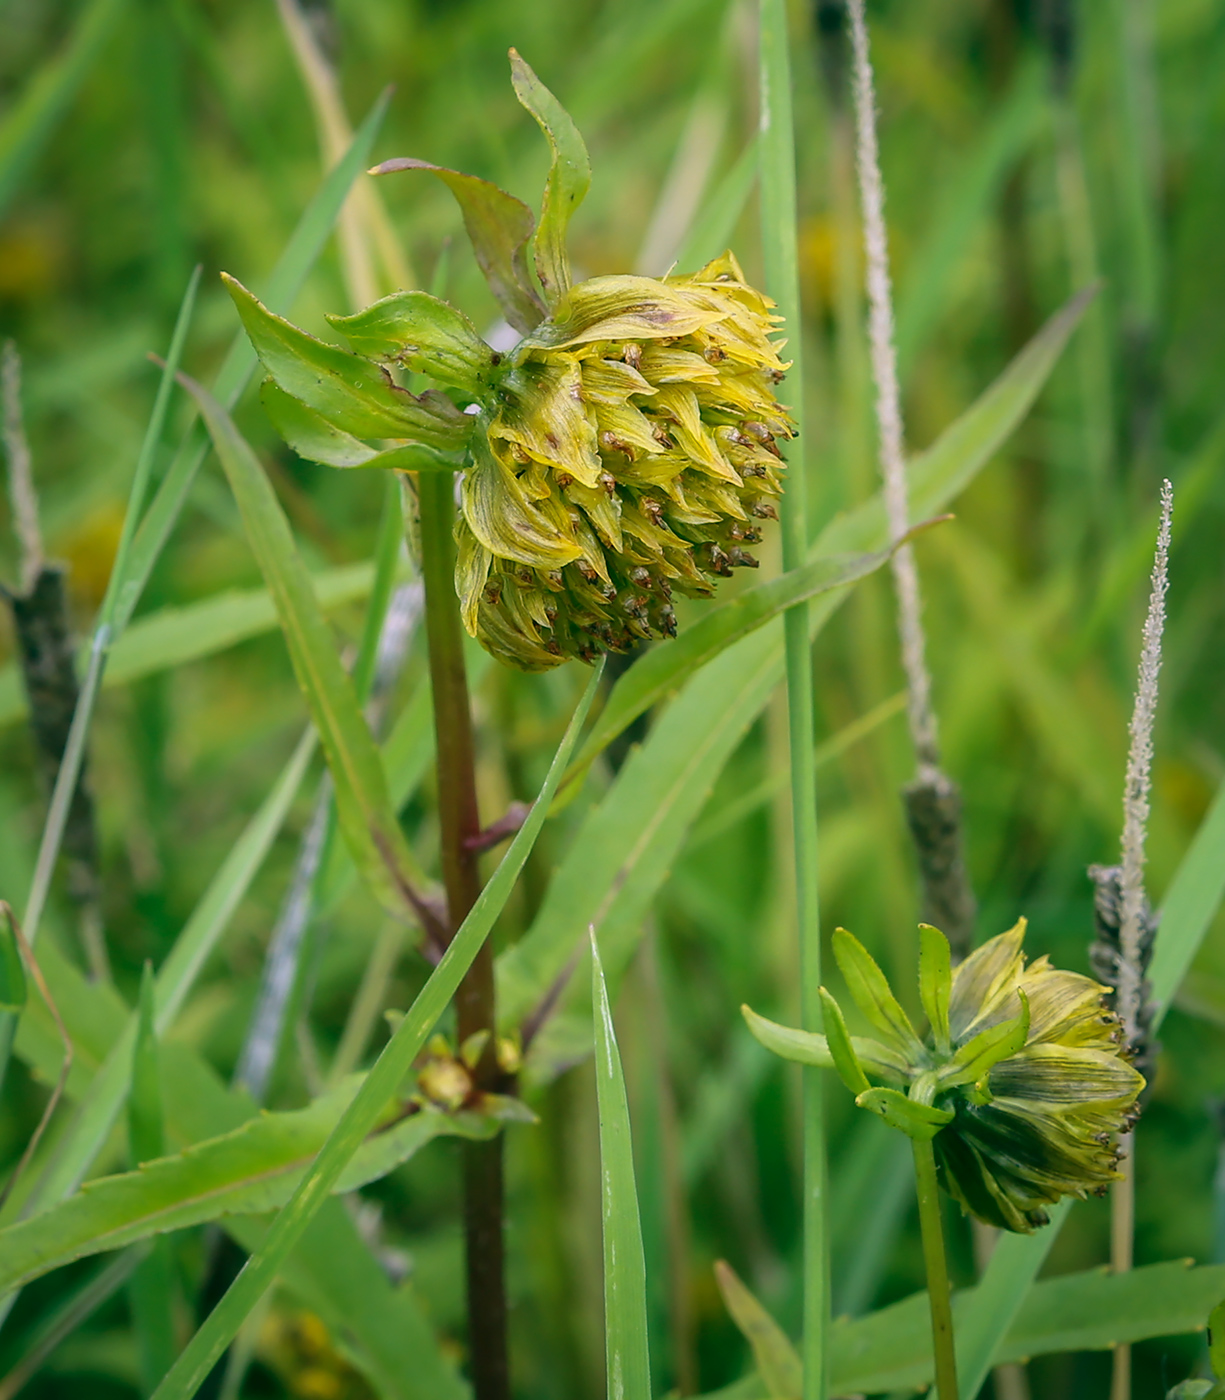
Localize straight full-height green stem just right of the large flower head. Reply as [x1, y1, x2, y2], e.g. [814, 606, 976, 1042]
[759, 0, 830, 1400]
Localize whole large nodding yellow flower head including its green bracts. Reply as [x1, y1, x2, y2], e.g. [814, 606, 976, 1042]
[228, 50, 794, 671]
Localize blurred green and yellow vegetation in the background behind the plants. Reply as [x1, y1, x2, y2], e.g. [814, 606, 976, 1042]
[0, 0, 1225, 1400]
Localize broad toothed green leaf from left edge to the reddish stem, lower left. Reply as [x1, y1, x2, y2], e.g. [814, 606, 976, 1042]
[0, 1075, 500, 1292]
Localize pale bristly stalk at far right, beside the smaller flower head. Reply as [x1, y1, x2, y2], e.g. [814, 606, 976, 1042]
[1110, 480, 1173, 1400]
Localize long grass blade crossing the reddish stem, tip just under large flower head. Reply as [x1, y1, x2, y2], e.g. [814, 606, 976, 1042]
[147, 666, 603, 1400]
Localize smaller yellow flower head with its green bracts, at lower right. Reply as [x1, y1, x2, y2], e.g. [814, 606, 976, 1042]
[745, 918, 1144, 1233]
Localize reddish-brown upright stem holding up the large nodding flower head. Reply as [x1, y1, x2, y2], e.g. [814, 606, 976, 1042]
[417, 472, 510, 1400]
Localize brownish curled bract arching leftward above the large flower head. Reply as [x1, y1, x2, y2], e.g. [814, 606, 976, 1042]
[370, 157, 546, 335]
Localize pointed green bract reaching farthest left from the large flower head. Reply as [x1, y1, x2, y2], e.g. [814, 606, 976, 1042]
[221, 281, 472, 452]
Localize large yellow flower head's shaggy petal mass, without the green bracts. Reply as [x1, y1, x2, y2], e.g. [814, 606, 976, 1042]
[456, 253, 792, 671]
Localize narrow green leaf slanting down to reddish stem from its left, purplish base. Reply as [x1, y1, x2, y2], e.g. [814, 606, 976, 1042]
[183, 377, 417, 921]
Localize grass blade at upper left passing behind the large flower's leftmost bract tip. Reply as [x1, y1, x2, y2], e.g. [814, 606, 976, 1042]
[115, 92, 391, 634]
